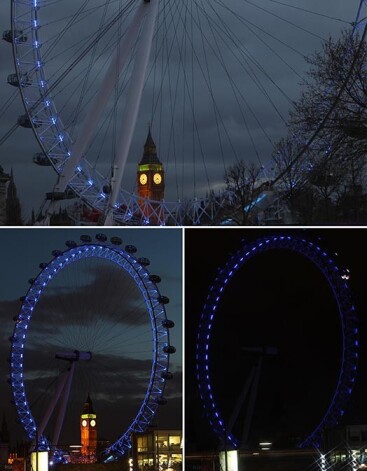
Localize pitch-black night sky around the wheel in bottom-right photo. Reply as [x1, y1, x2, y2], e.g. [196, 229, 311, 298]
[185, 229, 367, 450]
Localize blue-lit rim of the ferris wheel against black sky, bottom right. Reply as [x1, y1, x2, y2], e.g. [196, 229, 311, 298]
[196, 235, 358, 448]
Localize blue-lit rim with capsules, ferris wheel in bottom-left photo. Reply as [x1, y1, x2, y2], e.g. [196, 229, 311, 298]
[9, 238, 175, 459]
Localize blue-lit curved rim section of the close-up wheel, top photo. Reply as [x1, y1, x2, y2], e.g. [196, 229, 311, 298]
[12, 0, 367, 225]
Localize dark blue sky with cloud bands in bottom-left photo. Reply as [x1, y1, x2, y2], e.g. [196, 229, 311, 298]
[0, 229, 182, 444]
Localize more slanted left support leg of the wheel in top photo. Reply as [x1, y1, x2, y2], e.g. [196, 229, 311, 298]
[54, 4, 145, 192]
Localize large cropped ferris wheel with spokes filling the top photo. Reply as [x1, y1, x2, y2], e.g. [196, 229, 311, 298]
[4, 0, 367, 225]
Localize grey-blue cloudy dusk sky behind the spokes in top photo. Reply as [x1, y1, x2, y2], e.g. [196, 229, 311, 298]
[0, 0, 360, 219]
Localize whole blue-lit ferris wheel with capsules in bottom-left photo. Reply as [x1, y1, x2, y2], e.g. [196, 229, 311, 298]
[9, 234, 175, 460]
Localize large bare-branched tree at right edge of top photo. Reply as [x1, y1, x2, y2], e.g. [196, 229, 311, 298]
[280, 31, 367, 222]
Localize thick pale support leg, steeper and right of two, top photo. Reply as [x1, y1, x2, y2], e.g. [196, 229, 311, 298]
[105, 0, 158, 226]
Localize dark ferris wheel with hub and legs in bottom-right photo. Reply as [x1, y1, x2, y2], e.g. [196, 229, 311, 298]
[196, 234, 358, 450]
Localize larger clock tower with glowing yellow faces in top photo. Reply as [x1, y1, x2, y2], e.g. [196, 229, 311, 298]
[137, 128, 165, 223]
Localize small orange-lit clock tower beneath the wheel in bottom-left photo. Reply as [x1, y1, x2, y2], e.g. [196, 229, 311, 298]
[80, 394, 97, 463]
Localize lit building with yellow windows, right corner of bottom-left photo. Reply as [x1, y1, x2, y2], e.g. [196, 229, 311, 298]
[132, 430, 182, 471]
